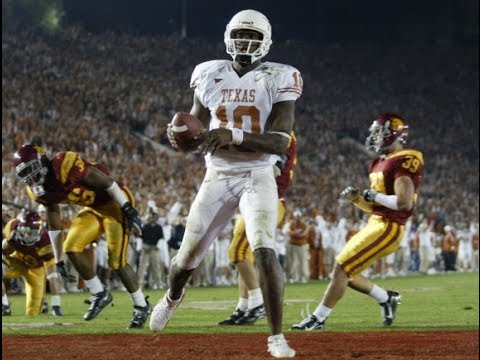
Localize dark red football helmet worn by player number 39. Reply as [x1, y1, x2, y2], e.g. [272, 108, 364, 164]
[365, 114, 408, 153]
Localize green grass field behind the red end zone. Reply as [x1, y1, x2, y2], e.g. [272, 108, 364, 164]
[2, 273, 479, 335]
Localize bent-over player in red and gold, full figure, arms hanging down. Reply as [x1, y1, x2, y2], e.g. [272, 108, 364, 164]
[13, 145, 151, 329]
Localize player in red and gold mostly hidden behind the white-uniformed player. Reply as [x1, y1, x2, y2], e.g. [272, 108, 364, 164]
[218, 131, 297, 325]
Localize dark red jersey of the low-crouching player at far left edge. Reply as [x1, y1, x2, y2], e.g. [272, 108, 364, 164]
[3, 219, 53, 268]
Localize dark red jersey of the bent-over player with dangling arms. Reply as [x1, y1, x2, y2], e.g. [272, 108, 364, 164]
[27, 151, 133, 208]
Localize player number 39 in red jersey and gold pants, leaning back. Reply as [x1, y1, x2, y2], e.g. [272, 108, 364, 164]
[292, 114, 423, 331]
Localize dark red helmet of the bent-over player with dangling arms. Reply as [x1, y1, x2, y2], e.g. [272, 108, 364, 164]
[13, 145, 48, 186]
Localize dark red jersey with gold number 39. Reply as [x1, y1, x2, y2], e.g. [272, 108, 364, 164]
[369, 149, 423, 225]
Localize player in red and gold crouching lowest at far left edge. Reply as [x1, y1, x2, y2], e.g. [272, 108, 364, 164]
[2, 211, 63, 316]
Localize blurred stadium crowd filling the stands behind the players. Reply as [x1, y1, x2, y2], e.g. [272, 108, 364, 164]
[2, 28, 479, 287]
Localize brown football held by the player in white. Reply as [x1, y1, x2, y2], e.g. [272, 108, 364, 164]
[169, 112, 205, 151]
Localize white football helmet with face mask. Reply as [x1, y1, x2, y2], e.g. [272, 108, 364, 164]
[224, 10, 272, 63]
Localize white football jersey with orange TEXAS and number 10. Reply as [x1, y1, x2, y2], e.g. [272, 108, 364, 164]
[190, 60, 303, 172]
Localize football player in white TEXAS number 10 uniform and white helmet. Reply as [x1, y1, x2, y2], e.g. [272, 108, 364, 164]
[150, 10, 302, 357]
